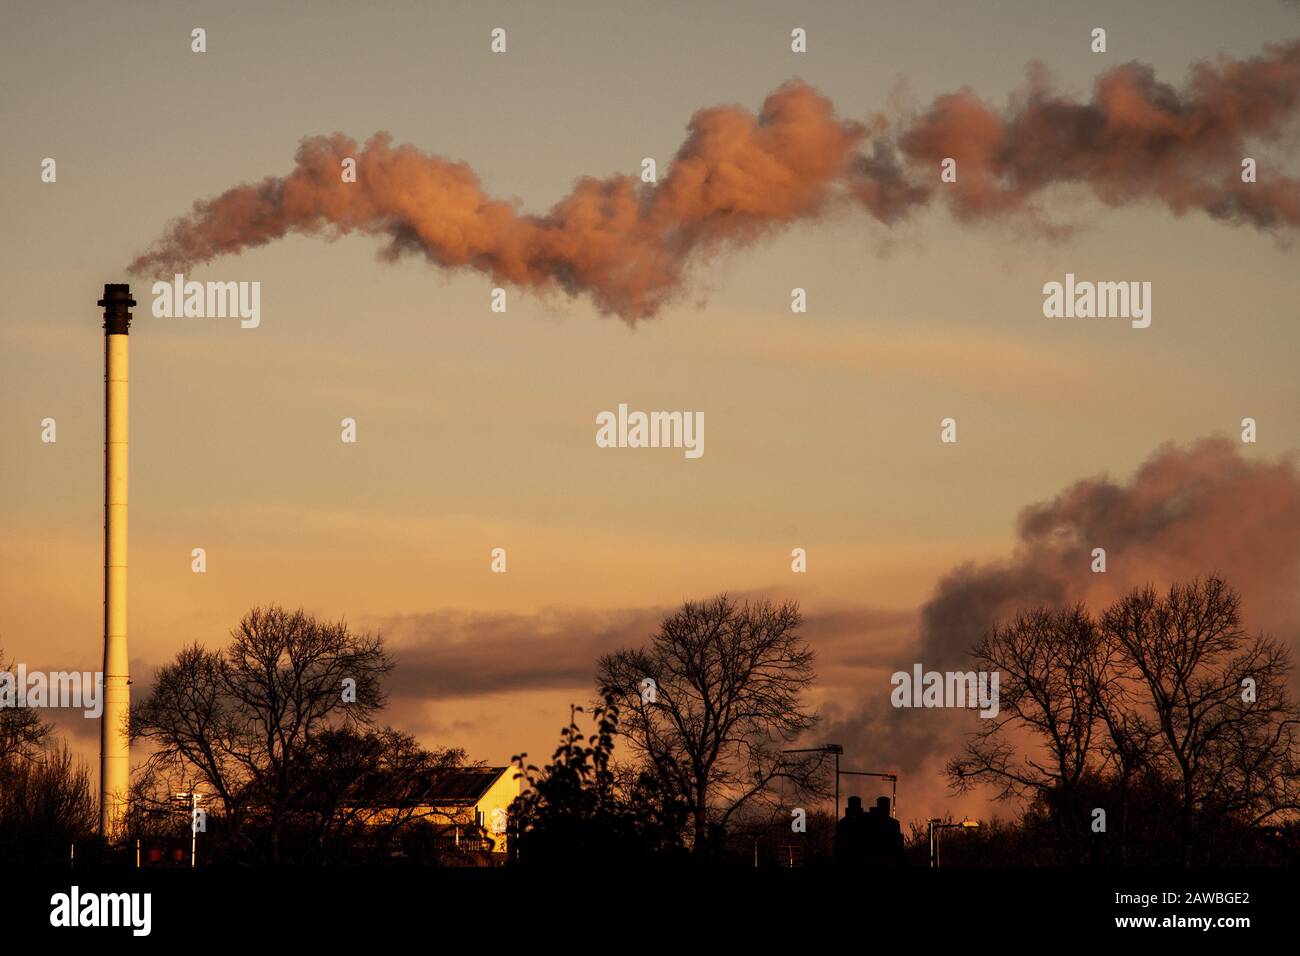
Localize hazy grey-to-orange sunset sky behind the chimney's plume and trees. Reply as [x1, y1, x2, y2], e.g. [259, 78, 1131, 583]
[0, 1, 1300, 819]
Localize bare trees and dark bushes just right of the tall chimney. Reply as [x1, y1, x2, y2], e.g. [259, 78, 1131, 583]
[131, 607, 480, 865]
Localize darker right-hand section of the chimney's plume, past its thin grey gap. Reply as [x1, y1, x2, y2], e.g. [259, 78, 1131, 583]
[889, 40, 1300, 235]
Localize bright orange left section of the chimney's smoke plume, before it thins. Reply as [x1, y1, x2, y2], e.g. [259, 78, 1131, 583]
[130, 82, 863, 320]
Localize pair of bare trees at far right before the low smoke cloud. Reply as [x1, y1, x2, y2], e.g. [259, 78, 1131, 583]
[948, 578, 1300, 864]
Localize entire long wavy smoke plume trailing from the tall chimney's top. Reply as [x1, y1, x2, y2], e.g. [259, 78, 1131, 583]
[130, 40, 1300, 323]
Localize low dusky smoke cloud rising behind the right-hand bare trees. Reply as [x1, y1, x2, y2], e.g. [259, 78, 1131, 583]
[823, 438, 1300, 810]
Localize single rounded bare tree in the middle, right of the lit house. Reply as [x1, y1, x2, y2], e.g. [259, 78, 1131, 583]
[597, 594, 820, 852]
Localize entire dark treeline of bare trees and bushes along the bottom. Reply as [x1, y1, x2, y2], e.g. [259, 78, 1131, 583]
[0, 578, 1300, 868]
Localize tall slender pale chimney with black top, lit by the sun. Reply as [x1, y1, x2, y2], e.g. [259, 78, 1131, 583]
[98, 282, 135, 842]
